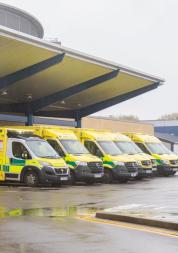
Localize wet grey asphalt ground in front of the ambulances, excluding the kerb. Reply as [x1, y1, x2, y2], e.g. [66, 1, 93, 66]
[0, 176, 178, 253]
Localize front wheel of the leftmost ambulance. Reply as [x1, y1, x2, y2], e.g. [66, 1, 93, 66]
[20, 166, 41, 186]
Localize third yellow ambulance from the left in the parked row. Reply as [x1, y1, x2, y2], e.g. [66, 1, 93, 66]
[74, 128, 138, 183]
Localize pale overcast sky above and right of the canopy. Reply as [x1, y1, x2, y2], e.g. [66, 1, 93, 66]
[1, 0, 178, 119]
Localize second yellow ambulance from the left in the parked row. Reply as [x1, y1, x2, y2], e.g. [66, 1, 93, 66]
[34, 126, 104, 184]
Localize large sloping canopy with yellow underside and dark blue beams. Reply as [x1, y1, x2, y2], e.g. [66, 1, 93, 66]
[0, 27, 164, 125]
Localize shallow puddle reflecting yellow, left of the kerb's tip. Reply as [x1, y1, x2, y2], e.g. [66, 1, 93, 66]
[0, 206, 102, 218]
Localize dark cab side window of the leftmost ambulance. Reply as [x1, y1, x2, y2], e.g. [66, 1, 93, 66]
[12, 141, 31, 159]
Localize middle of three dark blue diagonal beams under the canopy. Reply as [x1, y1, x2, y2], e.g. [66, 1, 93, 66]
[31, 69, 119, 112]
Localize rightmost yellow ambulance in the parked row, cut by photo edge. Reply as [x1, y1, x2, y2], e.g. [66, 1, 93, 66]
[124, 133, 178, 176]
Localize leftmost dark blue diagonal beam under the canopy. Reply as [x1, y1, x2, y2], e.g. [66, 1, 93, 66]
[0, 53, 65, 90]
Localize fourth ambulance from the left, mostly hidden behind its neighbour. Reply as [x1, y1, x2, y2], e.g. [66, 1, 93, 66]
[109, 133, 157, 179]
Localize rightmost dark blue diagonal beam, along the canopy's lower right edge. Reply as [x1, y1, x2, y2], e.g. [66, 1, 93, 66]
[78, 83, 159, 118]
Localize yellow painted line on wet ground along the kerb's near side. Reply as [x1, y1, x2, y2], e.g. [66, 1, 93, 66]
[77, 216, 178, 238]
